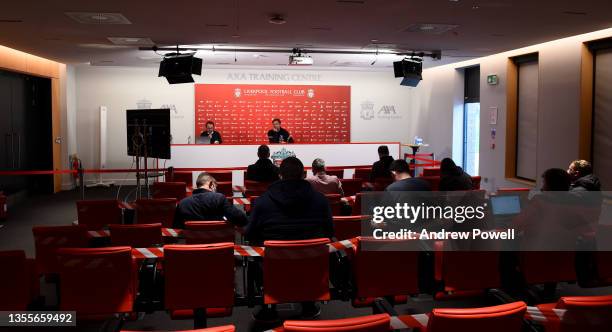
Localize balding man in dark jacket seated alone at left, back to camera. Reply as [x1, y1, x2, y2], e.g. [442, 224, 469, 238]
[173, 172, 248, 228]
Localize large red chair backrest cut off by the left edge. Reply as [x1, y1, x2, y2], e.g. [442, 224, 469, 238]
[0, 250, 40, 311]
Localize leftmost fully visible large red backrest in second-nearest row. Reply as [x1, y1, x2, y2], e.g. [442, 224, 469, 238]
[57, 247, 138, 315]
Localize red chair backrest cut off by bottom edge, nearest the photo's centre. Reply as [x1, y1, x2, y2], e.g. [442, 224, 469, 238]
[283, 314, 391, 332]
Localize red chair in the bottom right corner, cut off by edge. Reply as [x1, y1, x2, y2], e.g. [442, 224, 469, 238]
[537, 295, 612, 332]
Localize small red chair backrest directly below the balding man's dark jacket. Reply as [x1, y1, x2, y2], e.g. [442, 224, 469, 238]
[183, 220, 236, 244]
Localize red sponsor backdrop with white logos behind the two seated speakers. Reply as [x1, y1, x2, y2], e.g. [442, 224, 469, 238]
[195, 84, 351, 144]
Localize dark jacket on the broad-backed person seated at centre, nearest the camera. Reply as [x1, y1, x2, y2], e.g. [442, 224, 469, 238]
[246, 180, 334, 244]
